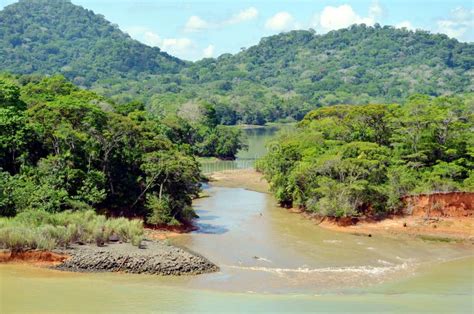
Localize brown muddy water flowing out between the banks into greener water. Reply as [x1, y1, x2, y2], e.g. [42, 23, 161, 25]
[174, 187, 472, 293]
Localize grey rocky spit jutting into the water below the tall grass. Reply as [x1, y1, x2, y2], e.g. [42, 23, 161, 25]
[52, 241, 219, 276]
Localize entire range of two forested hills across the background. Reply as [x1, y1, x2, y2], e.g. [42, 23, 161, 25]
[0, 0, 474, 124]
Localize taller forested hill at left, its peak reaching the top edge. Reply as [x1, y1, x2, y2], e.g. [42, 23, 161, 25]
[0, 0, 184, 86]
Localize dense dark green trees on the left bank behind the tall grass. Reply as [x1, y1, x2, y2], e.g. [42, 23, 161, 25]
[0, 75, 242, 232]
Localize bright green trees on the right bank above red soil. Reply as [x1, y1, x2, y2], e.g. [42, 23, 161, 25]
[258, 95, 474, 217]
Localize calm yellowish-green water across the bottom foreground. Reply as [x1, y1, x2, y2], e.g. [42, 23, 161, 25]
[0, 258, 474, 313]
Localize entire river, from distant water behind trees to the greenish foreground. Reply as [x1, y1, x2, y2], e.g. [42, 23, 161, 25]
[0, 128, 474, 313]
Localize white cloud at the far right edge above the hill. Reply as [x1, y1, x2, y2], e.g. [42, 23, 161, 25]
[436, 7, 474, 41]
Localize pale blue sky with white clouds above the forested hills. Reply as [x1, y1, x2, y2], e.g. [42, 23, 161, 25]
[0, 0, 474, 61]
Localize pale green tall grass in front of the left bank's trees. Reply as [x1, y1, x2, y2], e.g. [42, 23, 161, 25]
[0, 211, 144, 251]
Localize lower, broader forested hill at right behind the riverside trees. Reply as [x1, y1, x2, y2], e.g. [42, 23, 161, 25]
[176, 25, 474, 122]
